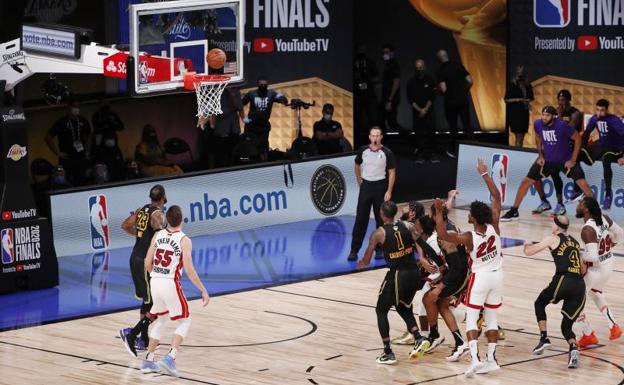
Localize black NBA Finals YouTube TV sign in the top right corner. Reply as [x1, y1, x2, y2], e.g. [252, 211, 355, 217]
[507, 0, 624, 86]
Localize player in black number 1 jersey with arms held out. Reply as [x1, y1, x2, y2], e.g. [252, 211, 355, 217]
[358, 201, 434, 365]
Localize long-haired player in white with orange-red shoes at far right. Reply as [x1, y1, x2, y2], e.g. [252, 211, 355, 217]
[576, 197, 624, 347]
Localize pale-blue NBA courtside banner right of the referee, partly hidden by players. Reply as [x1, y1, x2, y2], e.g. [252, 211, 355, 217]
[457, 144, 624, 222]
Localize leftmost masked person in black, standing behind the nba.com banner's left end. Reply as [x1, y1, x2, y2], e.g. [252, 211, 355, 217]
[45, 101, 91, 186]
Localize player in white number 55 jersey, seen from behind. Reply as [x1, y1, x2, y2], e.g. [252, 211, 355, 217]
[141, 206, 210, 377]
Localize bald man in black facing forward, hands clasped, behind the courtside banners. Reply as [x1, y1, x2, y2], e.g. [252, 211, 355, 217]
[406, 59, 440, 163]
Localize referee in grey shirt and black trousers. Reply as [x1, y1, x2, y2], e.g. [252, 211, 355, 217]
[347, 126, 396, 261]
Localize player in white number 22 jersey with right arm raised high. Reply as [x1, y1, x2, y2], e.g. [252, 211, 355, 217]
[434, 159, 503, 377]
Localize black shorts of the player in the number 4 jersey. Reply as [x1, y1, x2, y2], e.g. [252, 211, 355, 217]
[540, 275, 585, 321]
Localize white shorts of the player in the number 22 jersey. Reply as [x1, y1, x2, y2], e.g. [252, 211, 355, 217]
[464, 269, 503, 309]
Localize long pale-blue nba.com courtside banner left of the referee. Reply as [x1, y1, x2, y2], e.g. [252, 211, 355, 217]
[50, 155, 358, 256]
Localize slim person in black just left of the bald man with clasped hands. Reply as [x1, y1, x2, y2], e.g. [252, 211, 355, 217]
[381, 43, 401, 132]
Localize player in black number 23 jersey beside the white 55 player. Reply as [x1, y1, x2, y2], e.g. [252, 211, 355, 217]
[119, 184, 167, 357]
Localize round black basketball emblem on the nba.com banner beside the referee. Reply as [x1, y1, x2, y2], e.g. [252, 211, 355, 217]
[310, 164, 347, 215]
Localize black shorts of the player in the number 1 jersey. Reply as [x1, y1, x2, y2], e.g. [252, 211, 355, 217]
[378, 268, 420, 307]
